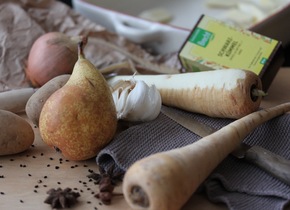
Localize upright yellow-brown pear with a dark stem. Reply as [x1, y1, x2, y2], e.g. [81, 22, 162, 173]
[39, 41, 117, 160]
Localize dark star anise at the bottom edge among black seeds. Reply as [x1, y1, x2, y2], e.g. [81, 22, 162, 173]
[44, 188, 80, 209]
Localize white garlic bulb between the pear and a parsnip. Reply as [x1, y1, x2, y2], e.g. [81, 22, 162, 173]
[111, 79, 161, 122]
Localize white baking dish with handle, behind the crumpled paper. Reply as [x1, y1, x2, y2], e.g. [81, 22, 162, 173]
[72, 0, 289, 54]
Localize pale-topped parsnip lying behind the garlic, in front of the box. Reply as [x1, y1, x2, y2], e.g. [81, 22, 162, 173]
[108, 69, 262, 119]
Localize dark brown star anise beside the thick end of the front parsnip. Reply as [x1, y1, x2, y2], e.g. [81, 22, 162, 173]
[88, 166, 124, 205]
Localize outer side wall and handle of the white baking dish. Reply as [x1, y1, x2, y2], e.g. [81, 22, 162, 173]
[73, 0, 195, 53]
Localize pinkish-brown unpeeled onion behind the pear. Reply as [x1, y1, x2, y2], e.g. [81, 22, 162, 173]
[25, 32, 80, 87]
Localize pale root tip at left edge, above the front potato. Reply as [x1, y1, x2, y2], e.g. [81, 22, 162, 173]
[0, 88, 37, 113]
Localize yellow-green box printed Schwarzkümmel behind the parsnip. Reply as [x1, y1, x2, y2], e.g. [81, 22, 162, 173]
[179, 15, 281, 90]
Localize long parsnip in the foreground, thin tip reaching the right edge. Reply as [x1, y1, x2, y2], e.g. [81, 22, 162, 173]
[123, 102, 290, 210]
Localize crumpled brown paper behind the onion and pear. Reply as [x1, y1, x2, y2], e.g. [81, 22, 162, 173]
[0, 0, 179, 92]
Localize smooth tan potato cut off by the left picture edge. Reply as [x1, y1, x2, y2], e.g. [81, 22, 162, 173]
[0, 110, 34, 156]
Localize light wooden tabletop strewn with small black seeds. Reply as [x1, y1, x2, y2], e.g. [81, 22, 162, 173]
[0, 68, 290, 210]
